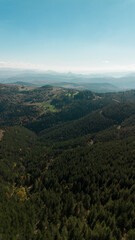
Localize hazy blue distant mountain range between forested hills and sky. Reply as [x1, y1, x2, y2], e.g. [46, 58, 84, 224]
[0, 69, 135, 92]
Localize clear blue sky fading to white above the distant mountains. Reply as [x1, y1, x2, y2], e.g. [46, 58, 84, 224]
[0, 0, 135, 72]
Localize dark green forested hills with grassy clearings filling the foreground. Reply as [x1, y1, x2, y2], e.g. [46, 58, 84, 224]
[0, 84, 135, 240]
